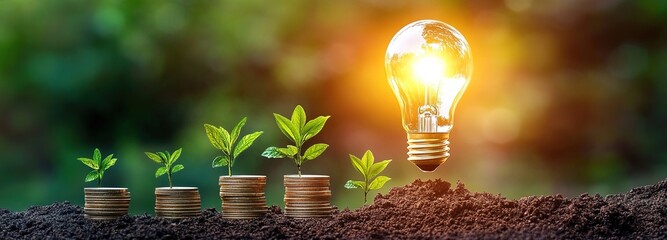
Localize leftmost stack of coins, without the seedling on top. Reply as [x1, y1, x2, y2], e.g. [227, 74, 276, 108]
[83, 188, 130, 220]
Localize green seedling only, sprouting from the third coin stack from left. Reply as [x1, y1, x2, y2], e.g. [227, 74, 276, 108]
[204, 117, 263, 176]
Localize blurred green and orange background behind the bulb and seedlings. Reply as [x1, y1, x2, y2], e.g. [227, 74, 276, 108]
[0, 0, 667, 214]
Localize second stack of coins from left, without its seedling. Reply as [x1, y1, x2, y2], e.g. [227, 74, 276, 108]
[155, 187, 201, 218]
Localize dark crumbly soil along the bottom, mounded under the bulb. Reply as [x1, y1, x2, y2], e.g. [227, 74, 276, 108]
[0, 180, 667, 239]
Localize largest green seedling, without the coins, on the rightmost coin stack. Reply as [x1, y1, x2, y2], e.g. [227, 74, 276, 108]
[262, 105, 329, 176]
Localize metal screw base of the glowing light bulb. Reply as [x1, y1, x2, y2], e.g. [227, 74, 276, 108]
[408, 133, 449, 172]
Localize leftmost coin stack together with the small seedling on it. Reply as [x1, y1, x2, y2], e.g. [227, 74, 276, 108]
[77, 148, 130, 220]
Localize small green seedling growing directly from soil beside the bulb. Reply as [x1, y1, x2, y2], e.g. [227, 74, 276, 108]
[345, 150, 391, 204]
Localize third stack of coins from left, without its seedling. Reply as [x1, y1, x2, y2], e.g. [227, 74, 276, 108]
[219, 175, 267, 219]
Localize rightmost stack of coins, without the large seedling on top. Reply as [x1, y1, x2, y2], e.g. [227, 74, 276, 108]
[284, 175, 331, 218]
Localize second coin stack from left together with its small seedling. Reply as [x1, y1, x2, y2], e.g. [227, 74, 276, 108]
[145, 148, 201, 218]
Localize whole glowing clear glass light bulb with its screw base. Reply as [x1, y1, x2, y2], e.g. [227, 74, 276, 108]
[385, 20, 472, 172]
